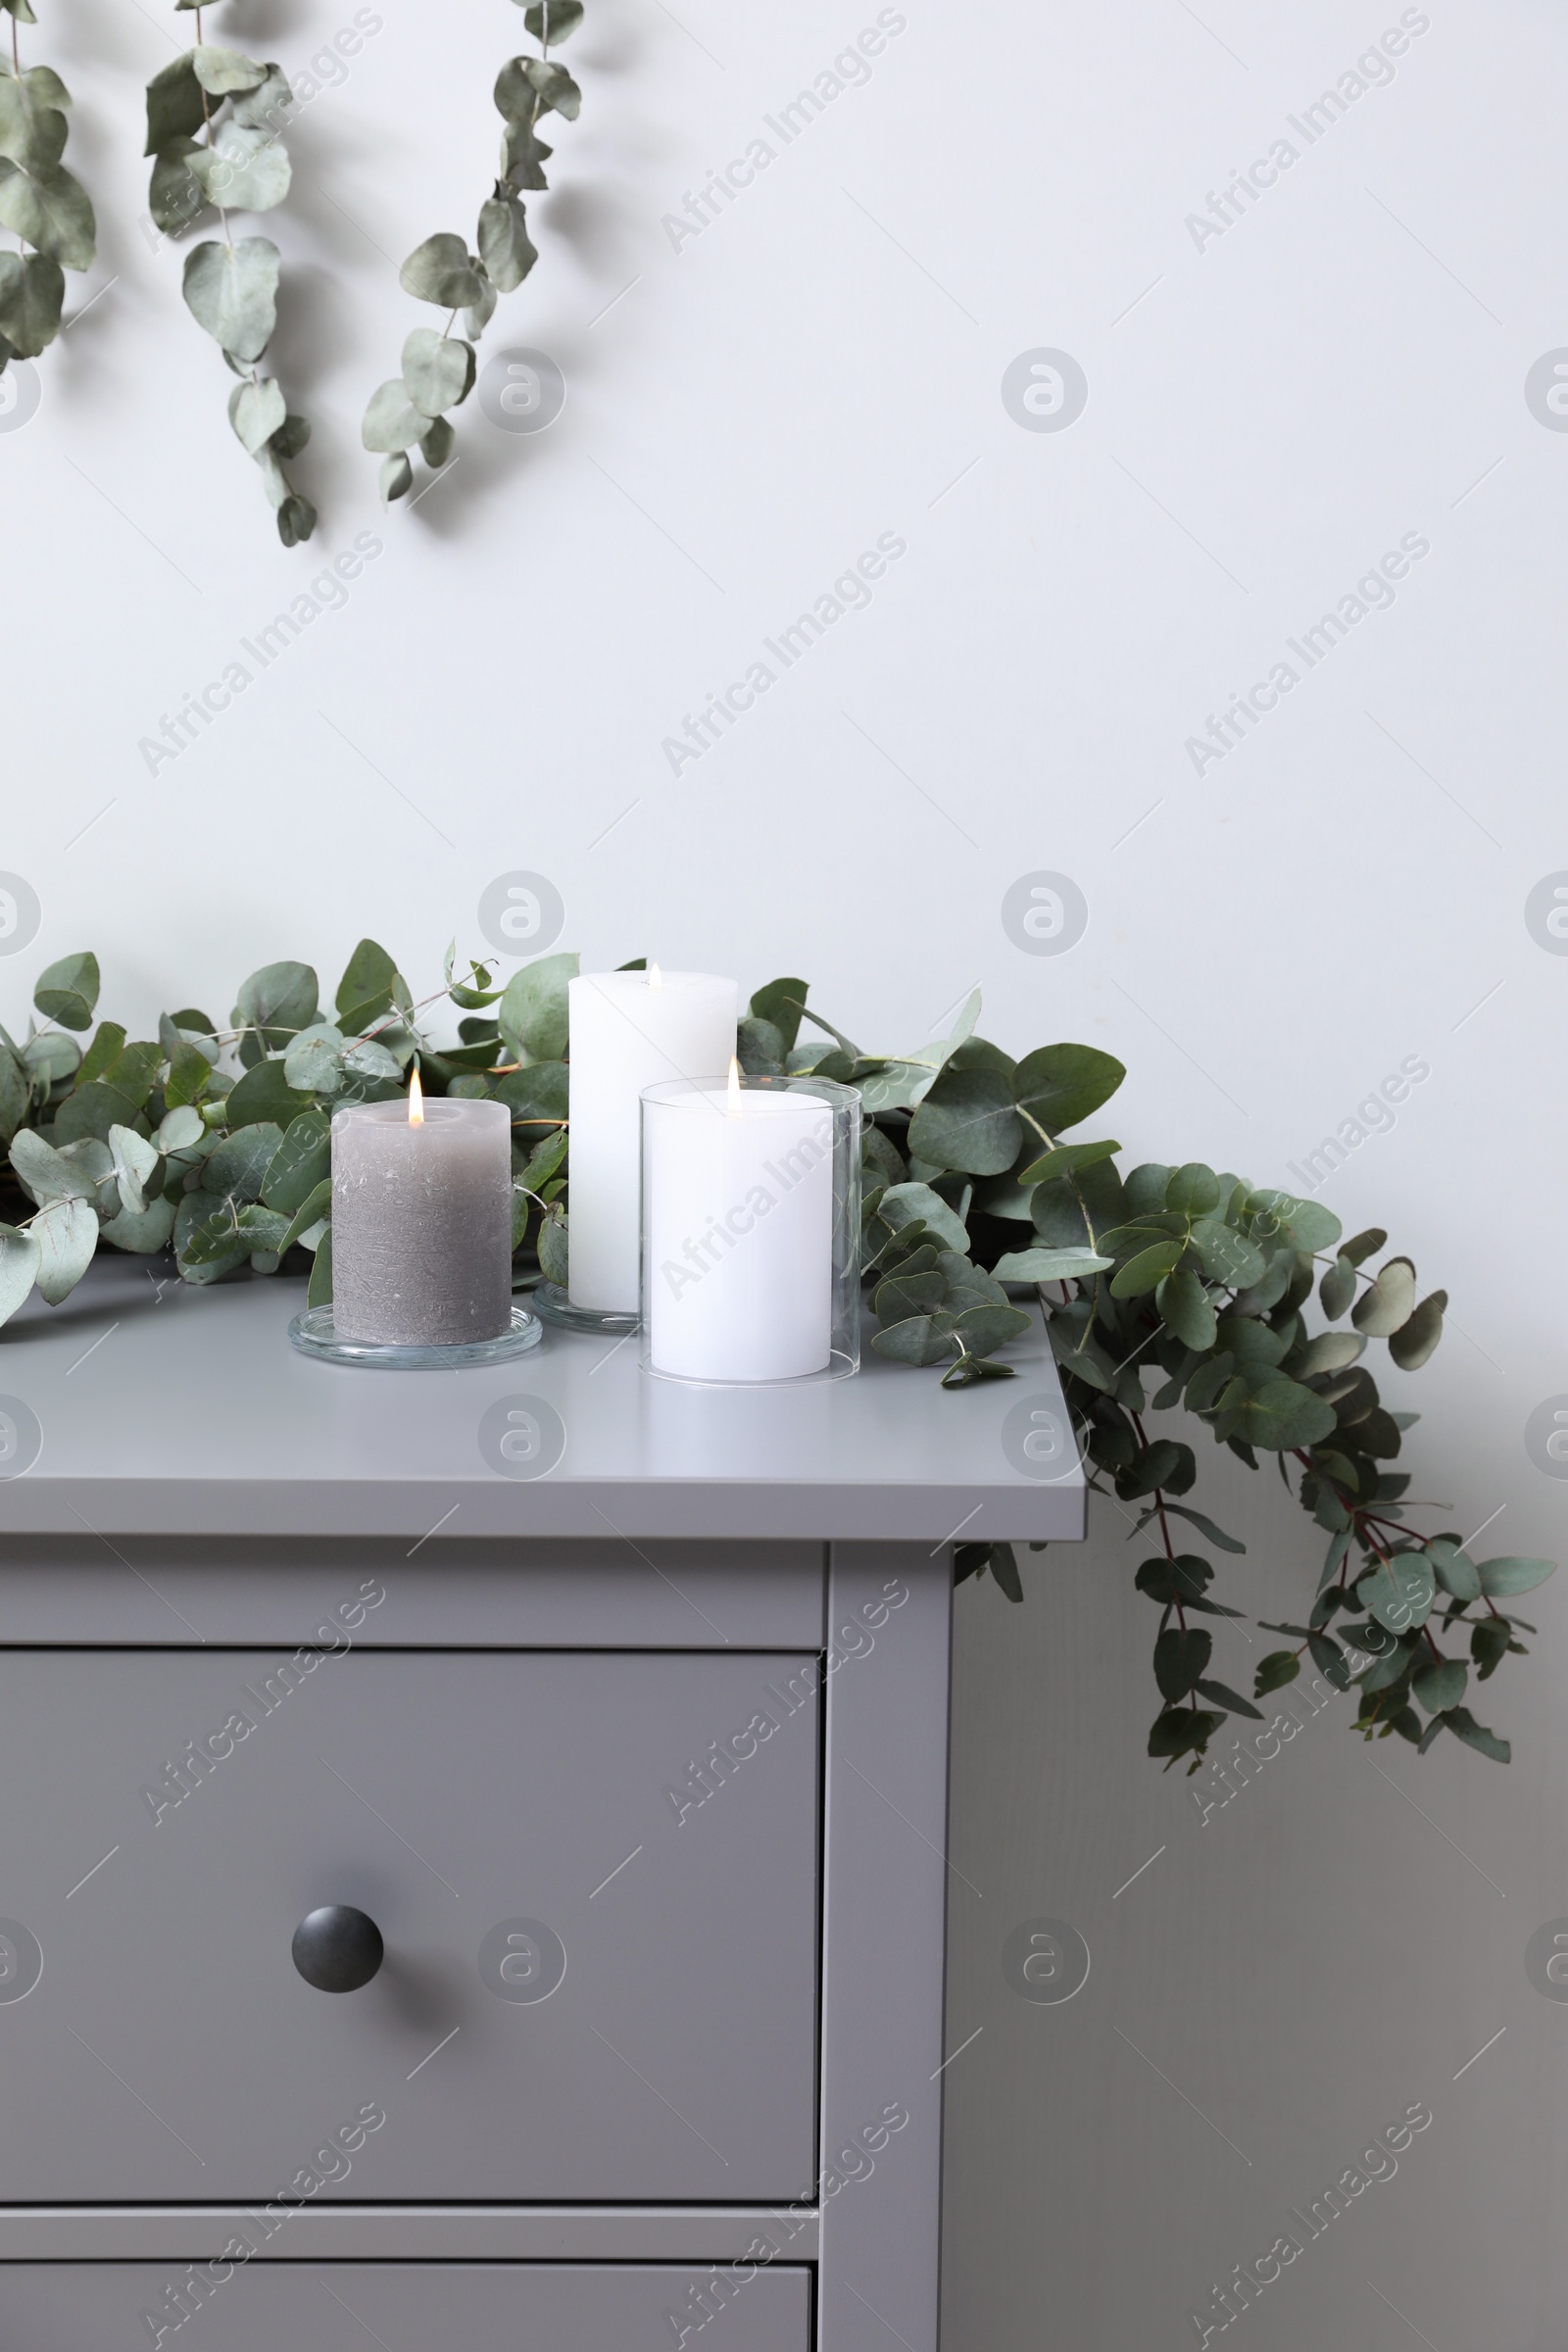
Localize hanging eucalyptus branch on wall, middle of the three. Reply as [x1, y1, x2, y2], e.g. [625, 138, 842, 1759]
[146, 0, 315, 548]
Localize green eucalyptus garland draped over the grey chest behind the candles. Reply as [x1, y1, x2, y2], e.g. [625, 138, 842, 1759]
[0, 939, 1554, 1769]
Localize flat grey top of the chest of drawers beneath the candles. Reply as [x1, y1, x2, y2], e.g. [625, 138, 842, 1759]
[0, 1251, 1084, 1557]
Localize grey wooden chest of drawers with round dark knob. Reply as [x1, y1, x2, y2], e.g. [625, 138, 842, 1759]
[0, 1263, 1084, 2352]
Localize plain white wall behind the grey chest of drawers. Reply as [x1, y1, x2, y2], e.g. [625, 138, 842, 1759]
[0, 0, 1568, 2352]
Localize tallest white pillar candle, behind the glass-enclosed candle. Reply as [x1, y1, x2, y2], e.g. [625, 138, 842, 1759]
[566, 966, 738, 1315]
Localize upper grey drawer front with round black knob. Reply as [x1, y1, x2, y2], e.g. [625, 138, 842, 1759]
[0, 1648, 820, 2201]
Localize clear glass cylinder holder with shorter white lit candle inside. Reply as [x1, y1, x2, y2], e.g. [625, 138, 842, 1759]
[642, 1075, 860, 1386]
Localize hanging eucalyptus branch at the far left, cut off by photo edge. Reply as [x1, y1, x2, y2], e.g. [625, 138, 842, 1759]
[0, 0, 96, 371]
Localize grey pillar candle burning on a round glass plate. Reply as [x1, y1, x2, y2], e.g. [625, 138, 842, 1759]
[331, 1096, 513, 1348]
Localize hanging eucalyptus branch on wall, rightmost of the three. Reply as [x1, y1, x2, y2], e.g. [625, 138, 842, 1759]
[360, 0, 583, 501]
